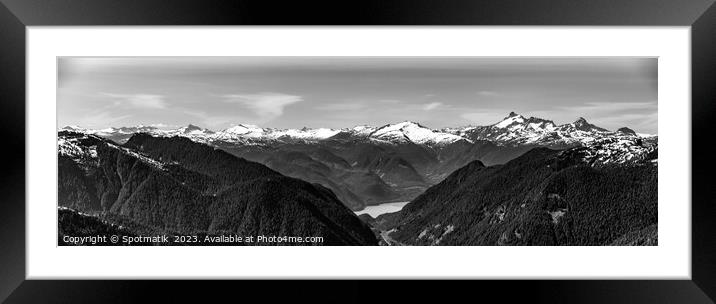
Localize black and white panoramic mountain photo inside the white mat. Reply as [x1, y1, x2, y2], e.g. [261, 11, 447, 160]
[57, 56, 658, 246]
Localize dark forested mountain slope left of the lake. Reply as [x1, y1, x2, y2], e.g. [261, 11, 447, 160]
[58, 131, 376, 245]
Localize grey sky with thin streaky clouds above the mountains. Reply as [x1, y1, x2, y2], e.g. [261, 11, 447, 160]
[57, 57, 657, 134]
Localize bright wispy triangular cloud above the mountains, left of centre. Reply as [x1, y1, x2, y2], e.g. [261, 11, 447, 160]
[222, 92, 303, 121]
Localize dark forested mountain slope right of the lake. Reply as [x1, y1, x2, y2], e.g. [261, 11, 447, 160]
[373, 148, 658, 246]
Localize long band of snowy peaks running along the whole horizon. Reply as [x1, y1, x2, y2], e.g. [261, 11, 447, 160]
[62, 112, 650, 148]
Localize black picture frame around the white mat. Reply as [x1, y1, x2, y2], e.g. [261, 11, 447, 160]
[0, 0, 716, 303]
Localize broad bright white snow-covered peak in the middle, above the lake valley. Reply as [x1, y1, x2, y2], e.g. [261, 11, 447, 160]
[369, 121, 465, 145]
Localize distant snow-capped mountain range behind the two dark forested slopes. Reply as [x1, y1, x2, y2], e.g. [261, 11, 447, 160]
[62, 112, 657, 210]
